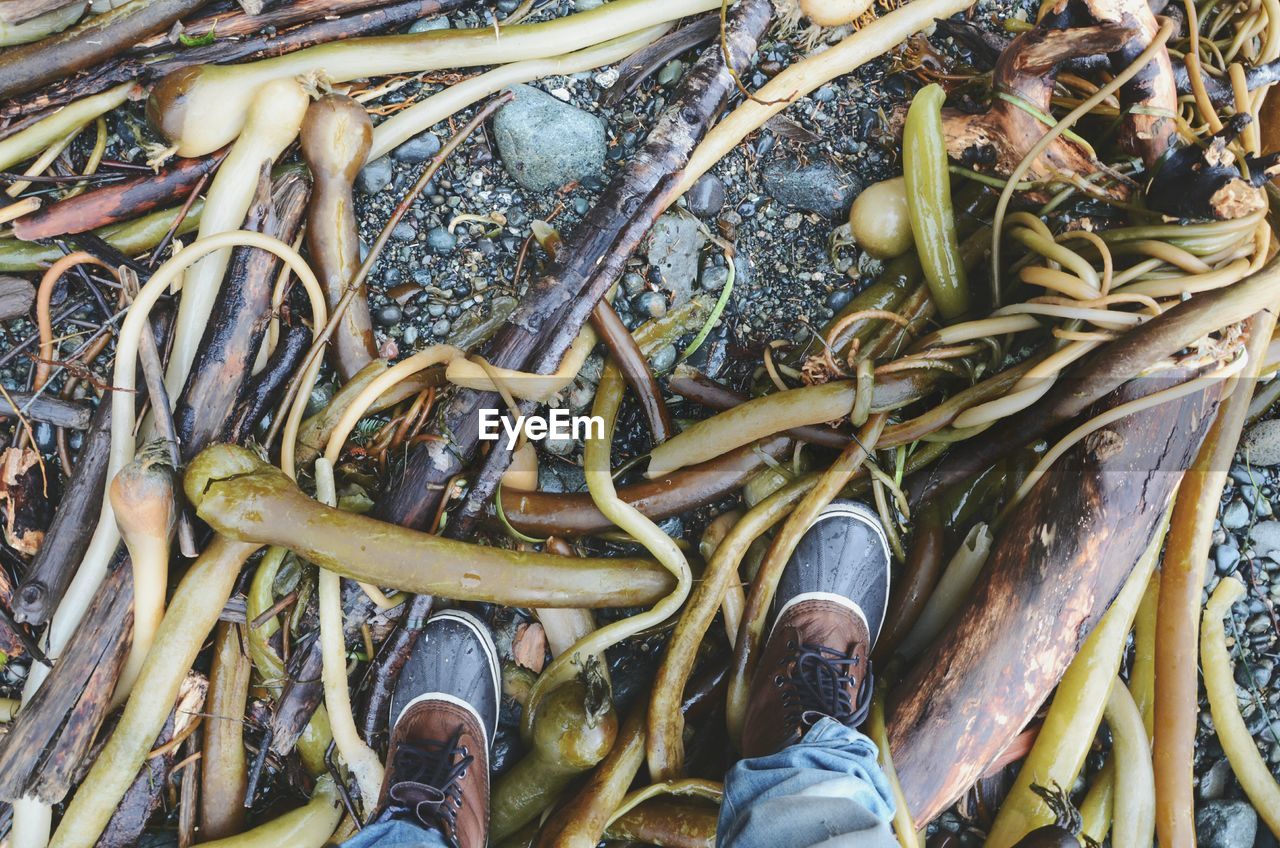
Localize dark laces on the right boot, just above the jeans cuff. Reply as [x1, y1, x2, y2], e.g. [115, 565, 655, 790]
[773, 640, 874, 729]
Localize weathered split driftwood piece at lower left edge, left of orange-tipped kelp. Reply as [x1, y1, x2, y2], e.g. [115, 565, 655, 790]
[0, 561, 133, 803]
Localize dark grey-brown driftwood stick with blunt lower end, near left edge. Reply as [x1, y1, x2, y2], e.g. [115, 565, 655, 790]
[13, 401, 111, 625]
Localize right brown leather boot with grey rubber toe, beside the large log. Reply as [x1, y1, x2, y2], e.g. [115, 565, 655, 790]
[742, 501, 890, 757]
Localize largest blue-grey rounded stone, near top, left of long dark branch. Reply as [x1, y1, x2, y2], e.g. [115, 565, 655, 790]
[493, 85, 605, 191]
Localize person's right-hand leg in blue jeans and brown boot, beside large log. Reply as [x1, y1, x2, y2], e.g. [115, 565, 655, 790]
[717, 502, 897, 848]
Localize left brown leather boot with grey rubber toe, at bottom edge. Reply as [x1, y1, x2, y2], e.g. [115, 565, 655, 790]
[378, 610, 500, 848]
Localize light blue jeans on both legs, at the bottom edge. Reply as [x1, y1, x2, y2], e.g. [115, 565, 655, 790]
[343, 719, 897, 848]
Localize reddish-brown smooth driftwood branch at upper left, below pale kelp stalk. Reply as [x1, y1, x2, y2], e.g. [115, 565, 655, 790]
[13, 149, 227, 241]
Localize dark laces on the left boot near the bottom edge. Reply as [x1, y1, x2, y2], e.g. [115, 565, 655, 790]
[388, 728, 475, 848]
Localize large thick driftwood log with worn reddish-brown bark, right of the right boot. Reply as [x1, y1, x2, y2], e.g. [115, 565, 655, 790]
[888, 371, 1221, 824]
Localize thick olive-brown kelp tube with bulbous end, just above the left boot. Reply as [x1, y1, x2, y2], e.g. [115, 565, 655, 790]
[184, 444, 675, 607]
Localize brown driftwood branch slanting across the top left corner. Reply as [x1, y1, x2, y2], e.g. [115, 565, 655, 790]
[0, 0, 206, 100]
